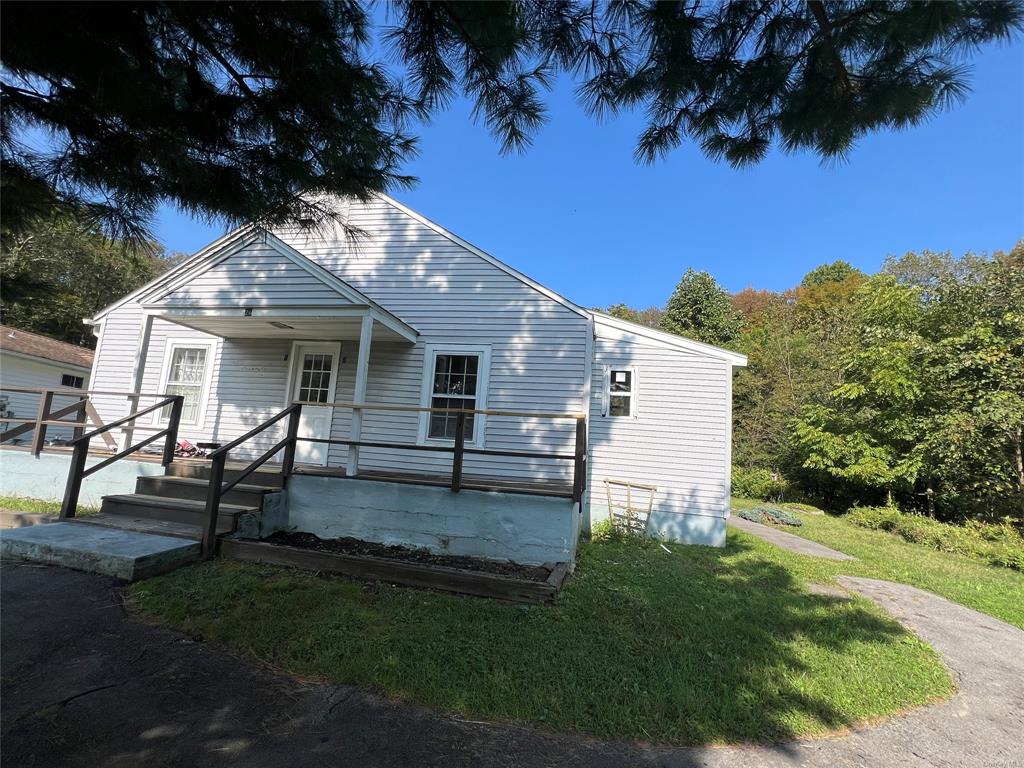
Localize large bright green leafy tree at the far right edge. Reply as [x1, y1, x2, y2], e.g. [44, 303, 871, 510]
[794, 243, 1024, 519]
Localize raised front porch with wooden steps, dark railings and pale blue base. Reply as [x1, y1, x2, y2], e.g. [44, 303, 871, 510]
[0, 382, 586, 581]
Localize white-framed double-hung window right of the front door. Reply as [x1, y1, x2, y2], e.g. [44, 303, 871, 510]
[424, 348, 487, 442]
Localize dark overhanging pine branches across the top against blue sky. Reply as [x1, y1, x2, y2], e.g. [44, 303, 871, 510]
[0, 0, 1024, 240]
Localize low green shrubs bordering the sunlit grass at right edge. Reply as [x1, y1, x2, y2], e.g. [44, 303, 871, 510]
[846, 506, 1024, 570]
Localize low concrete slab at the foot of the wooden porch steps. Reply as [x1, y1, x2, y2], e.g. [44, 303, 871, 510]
[0, 520, 200, 582]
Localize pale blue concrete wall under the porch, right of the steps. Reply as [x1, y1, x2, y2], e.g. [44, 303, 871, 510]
[288, 475, 580, 564]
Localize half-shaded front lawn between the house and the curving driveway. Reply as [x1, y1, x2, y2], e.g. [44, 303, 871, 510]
[129, 531, 952, 743]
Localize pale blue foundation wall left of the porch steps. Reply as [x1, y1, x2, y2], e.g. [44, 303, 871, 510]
[0, 449, 164, 507]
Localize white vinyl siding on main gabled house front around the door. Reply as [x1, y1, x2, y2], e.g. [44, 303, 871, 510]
[87, 201, 589, 479]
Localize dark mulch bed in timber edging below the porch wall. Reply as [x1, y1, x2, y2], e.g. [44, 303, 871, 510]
[263, 530, 551, 582]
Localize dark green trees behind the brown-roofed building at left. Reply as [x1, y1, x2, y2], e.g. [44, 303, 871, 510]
[0, 216, 179, 347]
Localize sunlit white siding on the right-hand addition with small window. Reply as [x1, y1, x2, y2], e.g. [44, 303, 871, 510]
[590, 324, 732, 539]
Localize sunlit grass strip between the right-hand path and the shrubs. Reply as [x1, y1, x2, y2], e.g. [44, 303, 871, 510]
[732, 499, 1024, 629]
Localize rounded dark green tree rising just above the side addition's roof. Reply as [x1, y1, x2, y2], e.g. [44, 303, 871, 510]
[662, 268, 743, 344]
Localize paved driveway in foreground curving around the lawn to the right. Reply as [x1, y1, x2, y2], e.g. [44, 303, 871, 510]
[0, 564, 1024, 768]
